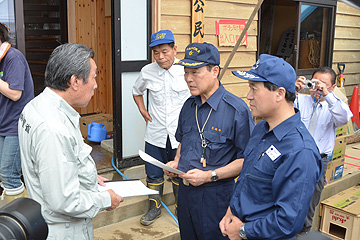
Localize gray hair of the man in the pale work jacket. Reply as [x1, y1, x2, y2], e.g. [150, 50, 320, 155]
[45, 43, 94, 91]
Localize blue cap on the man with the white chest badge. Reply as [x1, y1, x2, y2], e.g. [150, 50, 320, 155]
[232, 54, 296, 93]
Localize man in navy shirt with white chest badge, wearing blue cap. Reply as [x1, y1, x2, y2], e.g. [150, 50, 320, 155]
[219, 54, 322, 239]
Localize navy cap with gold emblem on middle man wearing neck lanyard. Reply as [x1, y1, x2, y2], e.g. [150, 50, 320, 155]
[175, 42, 220, 68]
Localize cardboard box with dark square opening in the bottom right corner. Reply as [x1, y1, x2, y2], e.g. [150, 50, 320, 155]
[320, 185, 360, 240]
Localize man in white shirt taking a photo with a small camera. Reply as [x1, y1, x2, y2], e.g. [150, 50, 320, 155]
[294, 67, 352, 234]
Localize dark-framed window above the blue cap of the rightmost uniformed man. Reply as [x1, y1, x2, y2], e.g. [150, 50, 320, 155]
[258, 0, 336, 75]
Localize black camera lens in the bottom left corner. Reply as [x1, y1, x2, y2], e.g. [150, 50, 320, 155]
[0, 198, 48, 240]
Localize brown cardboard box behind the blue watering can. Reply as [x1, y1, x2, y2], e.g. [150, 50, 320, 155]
[80, 113, 114, 138]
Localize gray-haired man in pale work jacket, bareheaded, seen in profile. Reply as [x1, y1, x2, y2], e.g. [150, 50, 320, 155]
[18, 43, 123, 240]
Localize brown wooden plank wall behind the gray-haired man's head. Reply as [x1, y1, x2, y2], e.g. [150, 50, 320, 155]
[68, 0, 113, 114]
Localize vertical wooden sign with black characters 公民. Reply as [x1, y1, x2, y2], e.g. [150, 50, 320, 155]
[191, 0, 205, 43]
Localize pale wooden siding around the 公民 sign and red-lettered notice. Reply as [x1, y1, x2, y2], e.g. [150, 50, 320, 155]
[159, 0, 258, 101]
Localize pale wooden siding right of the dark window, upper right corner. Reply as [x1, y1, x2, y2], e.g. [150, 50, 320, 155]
[332, 1, 360, 106]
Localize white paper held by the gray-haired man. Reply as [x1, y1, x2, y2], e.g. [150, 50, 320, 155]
[98, 180, 159, 197]
